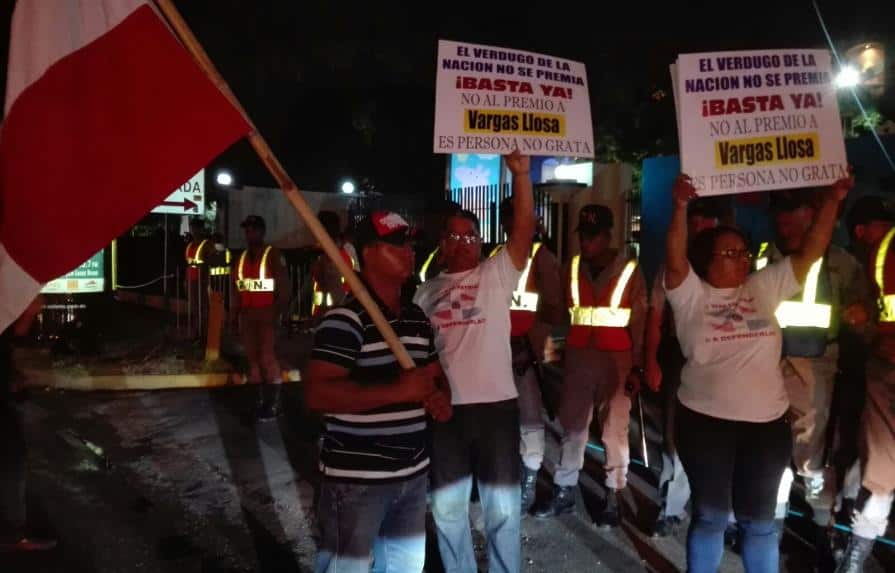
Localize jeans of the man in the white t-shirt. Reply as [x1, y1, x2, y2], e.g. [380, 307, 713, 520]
[432, 400, 522, 573]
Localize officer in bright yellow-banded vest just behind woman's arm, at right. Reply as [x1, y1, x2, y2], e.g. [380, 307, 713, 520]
[755, 189, 869, 562]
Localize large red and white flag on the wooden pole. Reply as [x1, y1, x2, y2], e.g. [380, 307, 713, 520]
[0, 0, 250, 331]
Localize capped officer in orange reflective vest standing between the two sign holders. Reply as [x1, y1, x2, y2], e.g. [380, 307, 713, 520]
[534, 205, 646, 526]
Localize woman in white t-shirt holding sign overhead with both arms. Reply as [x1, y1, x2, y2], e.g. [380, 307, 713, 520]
[665, 175, 853, 573]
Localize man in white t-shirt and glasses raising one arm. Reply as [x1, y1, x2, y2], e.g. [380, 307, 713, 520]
[414, 151, 535, 572]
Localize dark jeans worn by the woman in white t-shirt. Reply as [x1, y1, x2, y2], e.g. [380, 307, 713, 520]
[677, 397, 792, 573]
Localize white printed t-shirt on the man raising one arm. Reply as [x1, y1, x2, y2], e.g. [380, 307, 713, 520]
[413, 249, 522, 405]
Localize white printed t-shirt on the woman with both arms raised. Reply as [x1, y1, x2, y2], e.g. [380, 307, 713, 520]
[668, 258, 801, 422]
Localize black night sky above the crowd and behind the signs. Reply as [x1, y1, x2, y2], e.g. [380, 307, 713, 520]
[0, 0, 895, 193]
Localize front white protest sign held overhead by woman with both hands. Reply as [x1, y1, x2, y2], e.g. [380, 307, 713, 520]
[671, 50, 848, 195]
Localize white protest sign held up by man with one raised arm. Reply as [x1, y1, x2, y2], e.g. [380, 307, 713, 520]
[434, 40, 594, 158]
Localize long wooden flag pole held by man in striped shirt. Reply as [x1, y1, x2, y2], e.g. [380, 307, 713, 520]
[155, 0, 415, 369]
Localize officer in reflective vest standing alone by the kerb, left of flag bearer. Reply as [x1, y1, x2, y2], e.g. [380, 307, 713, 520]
[232, 215, 289, 421]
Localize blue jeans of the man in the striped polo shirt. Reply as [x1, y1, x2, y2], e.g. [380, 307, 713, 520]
[314, 474, 428, 573]
